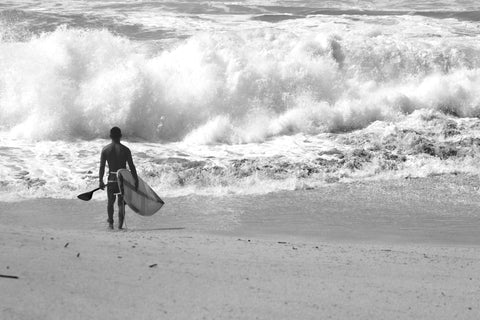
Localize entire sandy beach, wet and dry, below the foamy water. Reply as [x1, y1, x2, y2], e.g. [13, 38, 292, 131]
[0, 177, 480, 319]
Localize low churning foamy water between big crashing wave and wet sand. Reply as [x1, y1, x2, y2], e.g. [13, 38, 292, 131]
[0, 110, 480, 201]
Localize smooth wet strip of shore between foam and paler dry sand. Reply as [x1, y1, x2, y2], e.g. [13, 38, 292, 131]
[0, 176, 480, 245]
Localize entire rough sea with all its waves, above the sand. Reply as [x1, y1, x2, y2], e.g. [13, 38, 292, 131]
[0, 0, 480, 201]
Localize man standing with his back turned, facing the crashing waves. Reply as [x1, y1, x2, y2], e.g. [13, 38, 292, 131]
[98, 127, 138, 229]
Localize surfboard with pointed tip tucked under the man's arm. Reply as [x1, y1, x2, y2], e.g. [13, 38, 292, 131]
[117, 169, 165, 216]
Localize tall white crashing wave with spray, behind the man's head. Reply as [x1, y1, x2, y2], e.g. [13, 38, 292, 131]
[0, 27, 480, 144]
